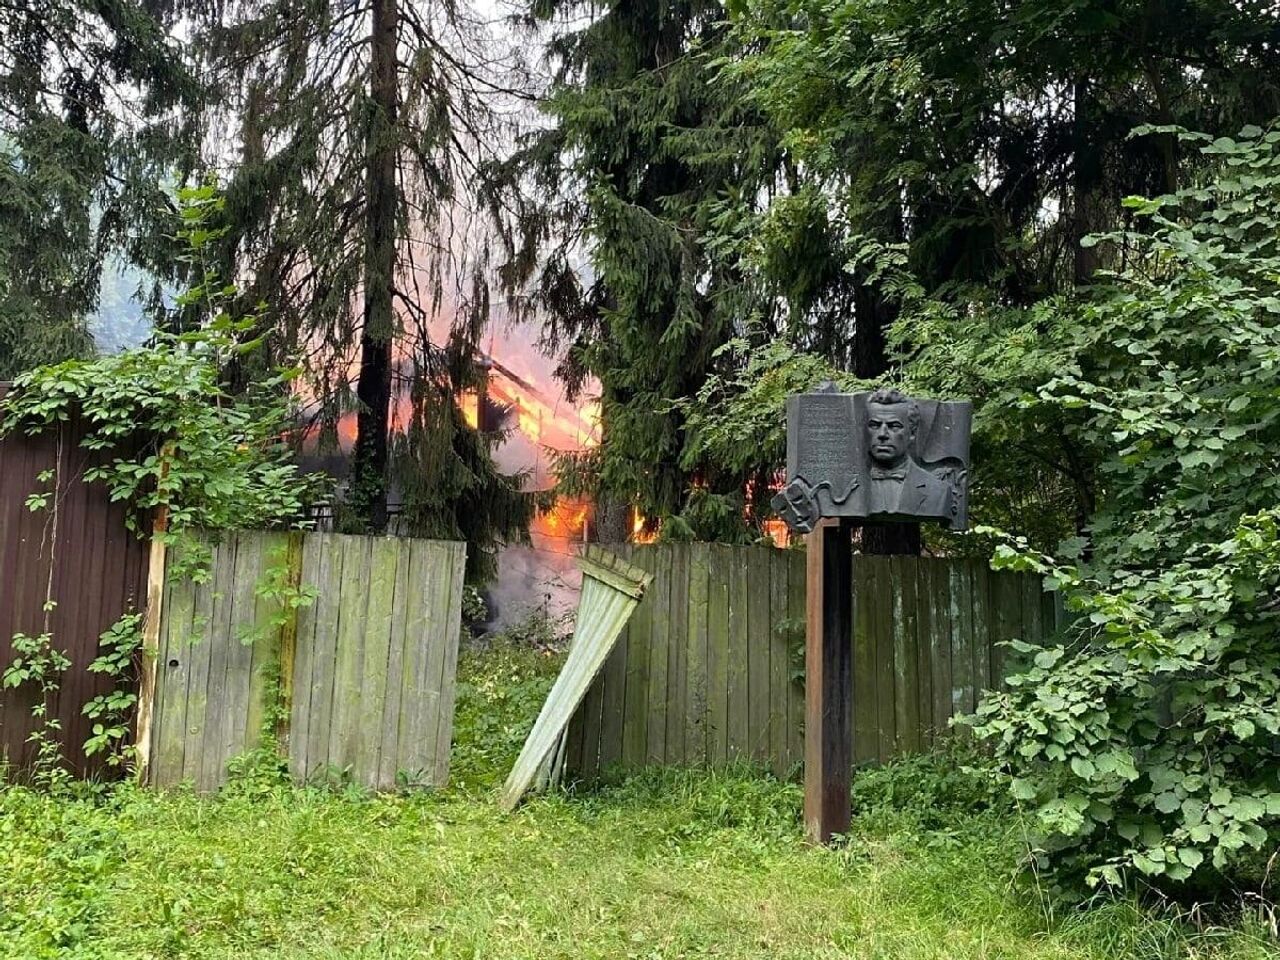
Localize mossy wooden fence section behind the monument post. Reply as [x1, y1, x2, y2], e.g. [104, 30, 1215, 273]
[564, 544, 1057, 778]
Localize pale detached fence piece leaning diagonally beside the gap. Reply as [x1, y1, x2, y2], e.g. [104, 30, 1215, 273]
[500, 547, 653, 810]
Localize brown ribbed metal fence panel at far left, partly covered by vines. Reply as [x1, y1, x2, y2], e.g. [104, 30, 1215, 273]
[0, 384, 147, 776]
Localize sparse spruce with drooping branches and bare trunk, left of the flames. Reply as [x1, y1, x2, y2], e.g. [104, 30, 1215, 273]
[200, 0, 534, 575]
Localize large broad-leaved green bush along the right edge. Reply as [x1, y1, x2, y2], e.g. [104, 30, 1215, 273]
[977, 128, 1280, 884]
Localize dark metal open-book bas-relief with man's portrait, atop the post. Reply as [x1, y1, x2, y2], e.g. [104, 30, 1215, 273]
[772, 385, 972, 532]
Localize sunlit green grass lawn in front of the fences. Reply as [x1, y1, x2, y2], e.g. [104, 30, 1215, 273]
[0, 648, 1276, 960]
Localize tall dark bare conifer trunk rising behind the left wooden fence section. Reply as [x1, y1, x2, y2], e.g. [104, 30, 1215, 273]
[349, 0, 398, 532]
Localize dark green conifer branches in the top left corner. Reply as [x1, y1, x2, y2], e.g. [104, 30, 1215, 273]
[0, 0, 200, 380]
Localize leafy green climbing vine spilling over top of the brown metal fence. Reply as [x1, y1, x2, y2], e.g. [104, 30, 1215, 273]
[0, 184, 317, 545]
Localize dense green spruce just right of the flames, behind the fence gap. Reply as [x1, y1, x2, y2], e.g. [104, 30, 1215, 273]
[489, 0, 777, 539]
